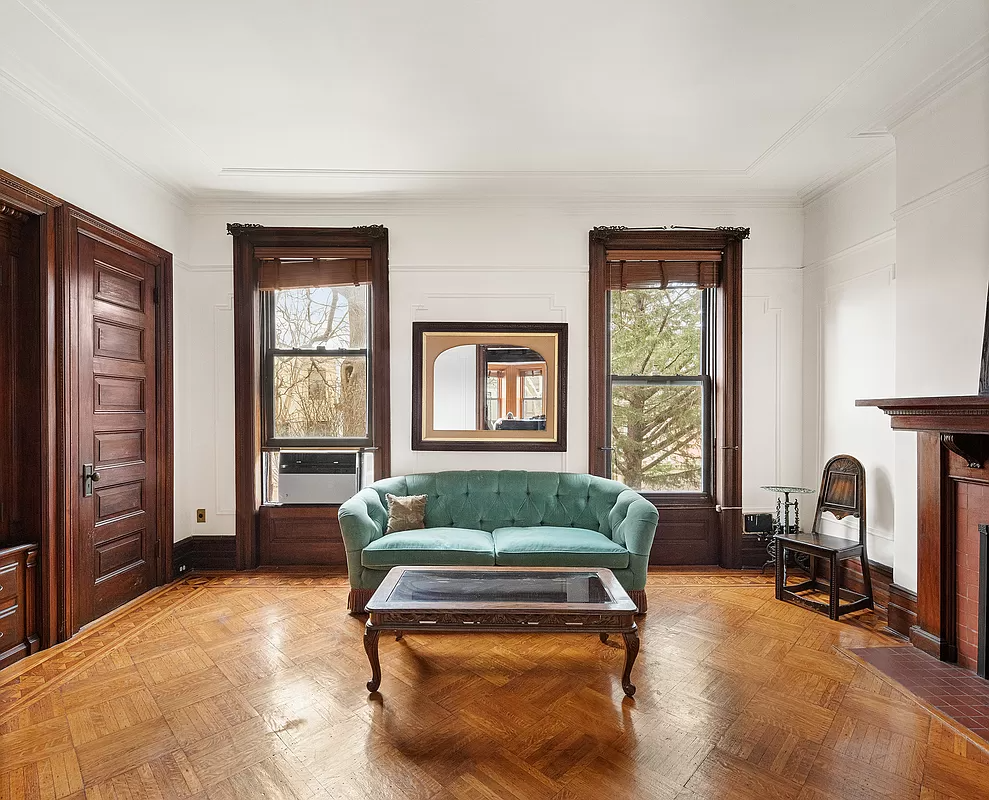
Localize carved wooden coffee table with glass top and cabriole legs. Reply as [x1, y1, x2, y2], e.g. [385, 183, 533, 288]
[364, 567, 639, 697]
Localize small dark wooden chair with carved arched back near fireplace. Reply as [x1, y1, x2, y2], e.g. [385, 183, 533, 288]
[776, 455, 875, 620]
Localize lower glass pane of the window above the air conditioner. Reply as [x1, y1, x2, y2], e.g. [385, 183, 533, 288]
[273, 356, 367, 439]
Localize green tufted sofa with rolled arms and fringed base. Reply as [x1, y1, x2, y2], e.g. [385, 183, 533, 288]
[339, 470, 659, 613]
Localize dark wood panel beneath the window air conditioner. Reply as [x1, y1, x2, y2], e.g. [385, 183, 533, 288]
[260, 505, 347, 567]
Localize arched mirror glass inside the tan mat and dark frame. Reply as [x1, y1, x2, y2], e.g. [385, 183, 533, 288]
[433, 344, 547, 431]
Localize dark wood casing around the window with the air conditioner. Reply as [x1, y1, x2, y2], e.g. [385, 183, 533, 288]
[227, 223, 391, 569]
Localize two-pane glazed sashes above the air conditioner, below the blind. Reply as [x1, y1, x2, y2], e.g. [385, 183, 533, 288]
[262, 284, 373, 447]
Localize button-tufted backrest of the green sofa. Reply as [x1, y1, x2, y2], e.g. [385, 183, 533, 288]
[370, 470, 628, 535]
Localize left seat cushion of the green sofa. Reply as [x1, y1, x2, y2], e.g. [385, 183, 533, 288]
[361, 528, 494, 569]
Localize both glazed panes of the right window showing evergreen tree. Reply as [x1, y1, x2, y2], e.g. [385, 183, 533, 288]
[607, 286, 713, 492]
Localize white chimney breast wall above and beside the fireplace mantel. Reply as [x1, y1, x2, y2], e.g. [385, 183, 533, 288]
[893, 68, 989, 589]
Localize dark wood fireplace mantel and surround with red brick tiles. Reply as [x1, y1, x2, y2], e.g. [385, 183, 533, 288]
[856, 395, 989, 683]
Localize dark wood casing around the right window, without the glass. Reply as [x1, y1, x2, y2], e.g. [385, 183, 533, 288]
[588, 226, 749, 568]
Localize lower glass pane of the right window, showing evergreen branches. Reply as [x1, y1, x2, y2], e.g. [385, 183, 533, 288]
[611, 385, 703, 492]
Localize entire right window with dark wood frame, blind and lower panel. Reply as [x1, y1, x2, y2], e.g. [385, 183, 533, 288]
[588, 227, 748, 568]
